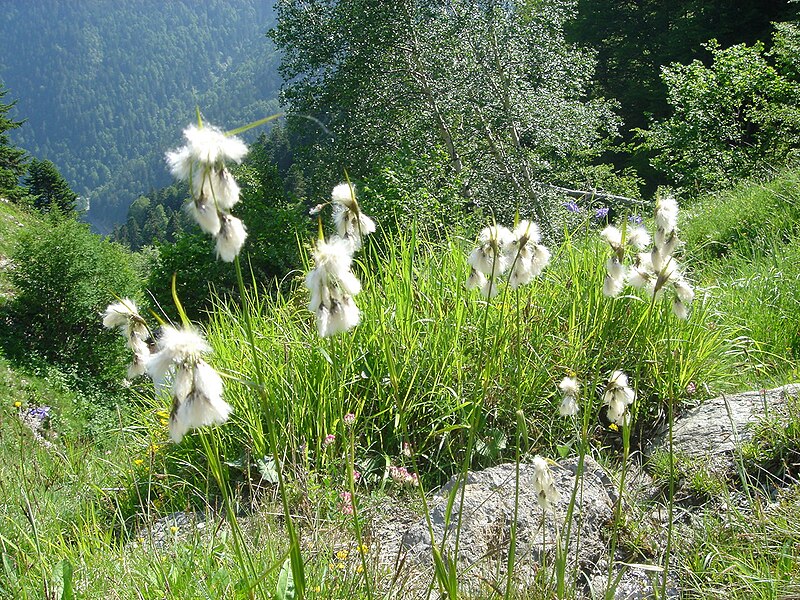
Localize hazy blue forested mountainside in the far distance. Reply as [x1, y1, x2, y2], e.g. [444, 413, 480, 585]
[0, 0, 280, 231]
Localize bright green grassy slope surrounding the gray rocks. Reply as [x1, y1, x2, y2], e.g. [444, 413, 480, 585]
[0, 174, 800, 600]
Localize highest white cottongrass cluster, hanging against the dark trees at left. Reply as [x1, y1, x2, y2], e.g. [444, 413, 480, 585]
[167, 125, 247, 262]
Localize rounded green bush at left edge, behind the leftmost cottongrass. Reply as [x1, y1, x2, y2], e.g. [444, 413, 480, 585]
[2, 219, 140, 380]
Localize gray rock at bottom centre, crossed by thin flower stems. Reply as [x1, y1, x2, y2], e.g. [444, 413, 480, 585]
[402, 457, 652, 598]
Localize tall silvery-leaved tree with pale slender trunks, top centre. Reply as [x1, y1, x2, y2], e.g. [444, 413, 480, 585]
[271, 0, 617, 230]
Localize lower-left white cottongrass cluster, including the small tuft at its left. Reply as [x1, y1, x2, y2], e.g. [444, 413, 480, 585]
[103, 298, 232, 443]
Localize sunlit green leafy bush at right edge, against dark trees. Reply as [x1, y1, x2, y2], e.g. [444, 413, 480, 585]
[642, 29, 800, 191]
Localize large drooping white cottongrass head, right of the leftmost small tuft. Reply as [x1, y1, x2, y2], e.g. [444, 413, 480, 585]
[147, 325, 232, 443]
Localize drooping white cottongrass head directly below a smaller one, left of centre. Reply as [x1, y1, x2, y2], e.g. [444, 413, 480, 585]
[306, 237, 361, 337]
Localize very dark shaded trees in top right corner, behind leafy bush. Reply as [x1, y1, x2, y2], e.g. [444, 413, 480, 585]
[567, 0, 797, 135]
